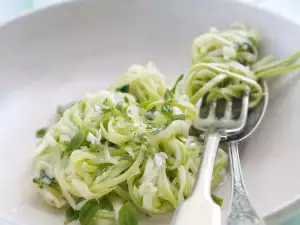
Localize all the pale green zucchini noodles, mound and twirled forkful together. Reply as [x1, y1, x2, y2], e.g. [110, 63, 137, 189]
[33, 25, 300, 225]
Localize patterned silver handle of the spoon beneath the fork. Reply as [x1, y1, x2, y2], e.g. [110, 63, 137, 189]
[227, 141, 264, 225]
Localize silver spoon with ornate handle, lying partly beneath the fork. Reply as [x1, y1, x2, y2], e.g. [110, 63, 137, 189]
[226, 80, 269, 225]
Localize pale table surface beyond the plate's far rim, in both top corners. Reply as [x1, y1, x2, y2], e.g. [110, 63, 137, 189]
[0, 0, 300, 23]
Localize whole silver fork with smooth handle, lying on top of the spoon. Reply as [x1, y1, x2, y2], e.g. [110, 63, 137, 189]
[171, 91, 249, 225]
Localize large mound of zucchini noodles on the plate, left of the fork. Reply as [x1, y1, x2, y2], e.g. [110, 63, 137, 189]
[34, 64, 227, 222]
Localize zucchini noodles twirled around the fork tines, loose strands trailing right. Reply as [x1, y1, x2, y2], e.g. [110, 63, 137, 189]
[181, 24, 300, 109]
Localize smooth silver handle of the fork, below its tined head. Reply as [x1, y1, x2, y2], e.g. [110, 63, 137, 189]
[171, 131, 221, 225]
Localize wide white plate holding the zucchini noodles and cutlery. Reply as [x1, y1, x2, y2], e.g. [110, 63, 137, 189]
[0, 0, 300, 225]
